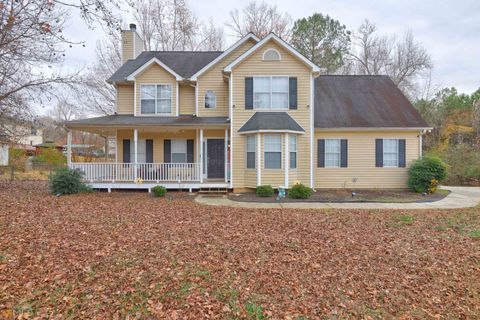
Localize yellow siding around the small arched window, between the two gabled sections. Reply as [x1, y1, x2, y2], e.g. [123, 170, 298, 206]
[197, 40, 255, 117]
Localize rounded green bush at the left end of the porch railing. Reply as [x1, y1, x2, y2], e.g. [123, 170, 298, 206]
[49, 168, 92, 194]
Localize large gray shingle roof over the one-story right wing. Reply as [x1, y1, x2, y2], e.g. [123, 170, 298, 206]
[315, 75, 429, 128]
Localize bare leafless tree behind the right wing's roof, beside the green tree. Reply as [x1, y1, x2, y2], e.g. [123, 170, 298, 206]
[349, 20, 433, 96]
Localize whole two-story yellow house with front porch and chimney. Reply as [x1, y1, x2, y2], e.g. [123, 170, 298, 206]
[65, 25, 430, 191]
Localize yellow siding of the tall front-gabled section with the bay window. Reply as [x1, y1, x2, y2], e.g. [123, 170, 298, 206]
[232, 41, 311, 188]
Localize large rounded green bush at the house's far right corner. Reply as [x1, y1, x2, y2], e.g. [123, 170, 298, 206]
[408, 156, 447, 193]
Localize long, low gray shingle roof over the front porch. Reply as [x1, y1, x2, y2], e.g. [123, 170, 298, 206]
[63, 115, 228, 128]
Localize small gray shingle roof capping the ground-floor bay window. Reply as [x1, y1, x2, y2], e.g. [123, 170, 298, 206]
[238, 112, 305, 132]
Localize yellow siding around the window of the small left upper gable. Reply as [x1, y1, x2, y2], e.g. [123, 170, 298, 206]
[136, 63, 177, 116]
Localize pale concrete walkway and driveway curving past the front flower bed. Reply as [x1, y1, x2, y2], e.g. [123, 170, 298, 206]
[195, 186, 480, 209]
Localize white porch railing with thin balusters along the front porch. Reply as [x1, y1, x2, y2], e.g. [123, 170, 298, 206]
[70, 162, 200, 182]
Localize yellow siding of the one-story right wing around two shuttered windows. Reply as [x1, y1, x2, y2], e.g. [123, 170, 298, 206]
[314, 131, 419, 188]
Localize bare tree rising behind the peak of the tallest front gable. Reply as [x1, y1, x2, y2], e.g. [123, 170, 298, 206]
[227, 1, 292, 40]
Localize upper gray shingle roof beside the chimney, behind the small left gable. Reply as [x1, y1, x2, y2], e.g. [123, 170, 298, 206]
[107, 51, 222, 82]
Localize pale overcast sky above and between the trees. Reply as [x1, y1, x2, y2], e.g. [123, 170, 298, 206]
[62, 0, 480, 93]
